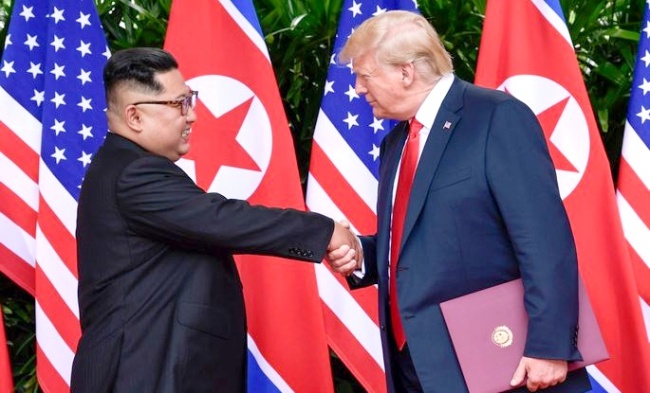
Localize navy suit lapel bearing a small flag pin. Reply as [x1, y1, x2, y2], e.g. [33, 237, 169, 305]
[400, 78, 466, 250]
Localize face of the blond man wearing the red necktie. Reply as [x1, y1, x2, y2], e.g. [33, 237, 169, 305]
[353, 53, 408, 120]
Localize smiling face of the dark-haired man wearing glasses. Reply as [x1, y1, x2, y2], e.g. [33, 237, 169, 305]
[131, 70, 196, 161]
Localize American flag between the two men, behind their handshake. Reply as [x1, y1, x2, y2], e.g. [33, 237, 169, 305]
[307, 0, 417, 392]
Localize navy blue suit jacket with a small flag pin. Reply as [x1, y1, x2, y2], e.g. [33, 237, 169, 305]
[349, 78, 589, 392]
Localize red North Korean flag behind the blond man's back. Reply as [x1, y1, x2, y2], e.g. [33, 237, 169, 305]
[476, 0, 650, 392]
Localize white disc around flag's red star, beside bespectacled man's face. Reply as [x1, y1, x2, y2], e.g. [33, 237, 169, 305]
[178, 75, 273, 199]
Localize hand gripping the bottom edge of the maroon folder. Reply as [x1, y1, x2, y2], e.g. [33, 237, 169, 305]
[510, 356, 568, 392]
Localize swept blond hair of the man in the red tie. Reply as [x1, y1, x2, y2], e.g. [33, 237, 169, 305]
[339, 11, 454, 82]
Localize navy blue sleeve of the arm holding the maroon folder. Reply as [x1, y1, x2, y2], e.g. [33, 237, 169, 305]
[486, 100, 580, 360]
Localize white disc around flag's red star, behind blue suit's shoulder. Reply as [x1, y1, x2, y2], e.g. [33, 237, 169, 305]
[498, 75, 590, 199]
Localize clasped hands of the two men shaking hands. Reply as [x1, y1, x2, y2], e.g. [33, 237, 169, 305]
[327, 221, 363, 276]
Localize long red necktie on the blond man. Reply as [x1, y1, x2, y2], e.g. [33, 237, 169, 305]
[389, 118, 422, 349]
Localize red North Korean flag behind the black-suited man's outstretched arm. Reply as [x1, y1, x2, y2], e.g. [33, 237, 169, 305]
[165, 0, 333, 392]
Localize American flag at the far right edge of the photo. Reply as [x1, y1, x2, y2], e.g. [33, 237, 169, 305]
[617, 1, 650, 350]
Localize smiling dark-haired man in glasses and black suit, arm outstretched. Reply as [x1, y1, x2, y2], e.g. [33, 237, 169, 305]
[71, 48, 356, 393]
